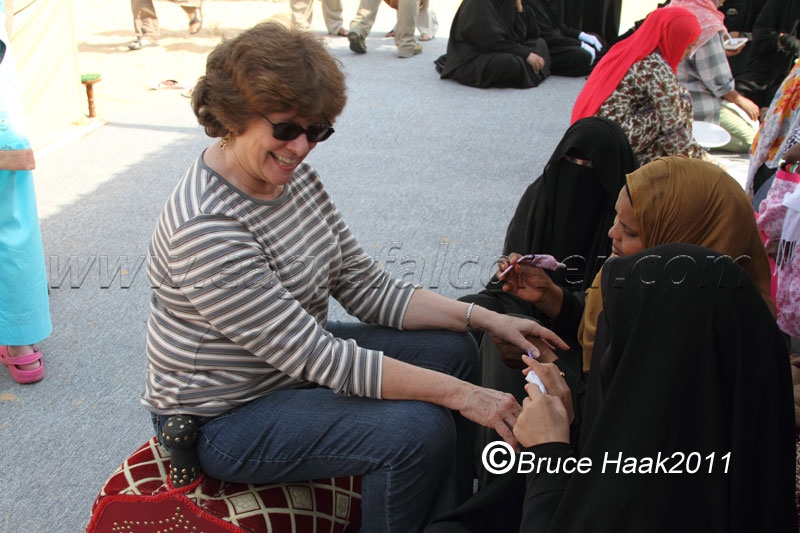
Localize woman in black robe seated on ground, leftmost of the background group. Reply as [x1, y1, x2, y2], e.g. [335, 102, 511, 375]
[434, 0, 550, 89]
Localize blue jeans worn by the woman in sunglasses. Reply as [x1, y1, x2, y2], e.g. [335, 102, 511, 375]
[152, 322, 478, 533]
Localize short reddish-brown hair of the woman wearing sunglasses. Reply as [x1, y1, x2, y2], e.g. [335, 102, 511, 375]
[192, 22, 347, 137]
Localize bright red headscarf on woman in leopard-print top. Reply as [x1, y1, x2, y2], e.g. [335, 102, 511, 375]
[570, 7, 701, 124]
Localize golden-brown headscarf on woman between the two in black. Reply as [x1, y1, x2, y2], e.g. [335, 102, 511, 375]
[578, 156, 775, 371]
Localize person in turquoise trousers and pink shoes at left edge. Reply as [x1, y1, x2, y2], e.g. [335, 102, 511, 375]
[0, 0, 53, 383]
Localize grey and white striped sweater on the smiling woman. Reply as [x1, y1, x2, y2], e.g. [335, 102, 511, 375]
[142, 156, 414, 416]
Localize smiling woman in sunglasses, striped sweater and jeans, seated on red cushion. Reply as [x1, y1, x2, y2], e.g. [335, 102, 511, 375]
[143, 23, 563, 532]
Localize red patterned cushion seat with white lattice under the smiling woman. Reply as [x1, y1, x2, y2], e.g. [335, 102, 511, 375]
[86, 437, 361, 533]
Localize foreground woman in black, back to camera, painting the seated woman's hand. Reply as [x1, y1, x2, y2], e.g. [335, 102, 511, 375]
[514, 244, 797, 533]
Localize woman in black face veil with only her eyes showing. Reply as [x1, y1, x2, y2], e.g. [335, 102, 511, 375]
[461, 117, 639, 374]
